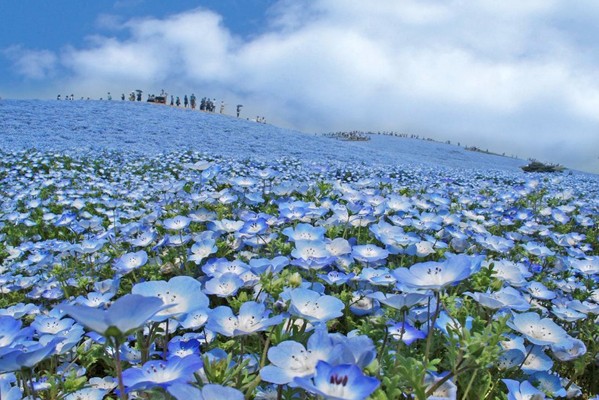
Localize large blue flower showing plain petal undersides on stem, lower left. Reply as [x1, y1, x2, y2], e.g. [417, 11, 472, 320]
[58, 294, 165, 337]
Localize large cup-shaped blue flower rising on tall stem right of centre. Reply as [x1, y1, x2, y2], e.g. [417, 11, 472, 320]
[392, 255, 482, 290]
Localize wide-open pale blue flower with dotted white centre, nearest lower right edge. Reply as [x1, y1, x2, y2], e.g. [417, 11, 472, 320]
[507, 312, 571, 346]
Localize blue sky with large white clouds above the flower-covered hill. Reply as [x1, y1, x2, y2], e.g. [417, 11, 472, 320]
[0, 0, 599, 173]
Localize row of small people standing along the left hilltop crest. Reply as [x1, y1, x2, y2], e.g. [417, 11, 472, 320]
[56, 89, 266, 124]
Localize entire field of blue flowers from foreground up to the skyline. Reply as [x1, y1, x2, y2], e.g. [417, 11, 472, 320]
[0, 101, 599, 400]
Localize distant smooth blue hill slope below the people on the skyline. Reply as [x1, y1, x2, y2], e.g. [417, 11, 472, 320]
[0, 100, 526, 172]
